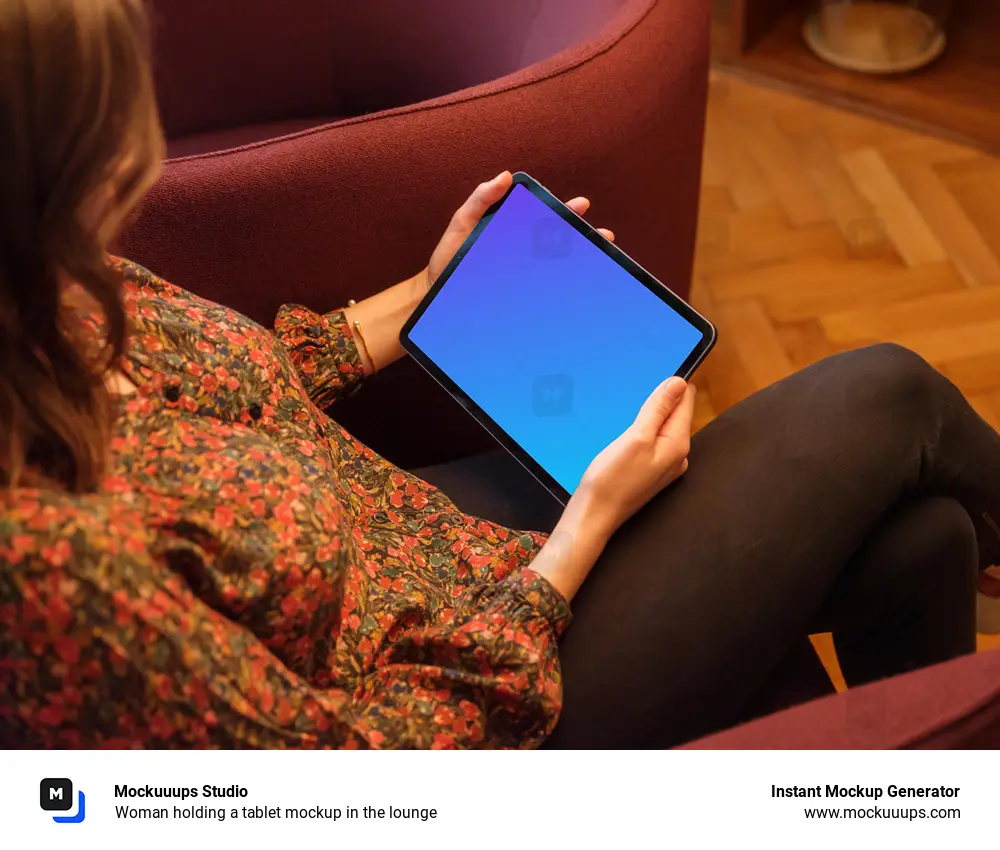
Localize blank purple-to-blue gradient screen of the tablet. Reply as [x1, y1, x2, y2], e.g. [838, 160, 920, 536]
[409, 185, 702, 493]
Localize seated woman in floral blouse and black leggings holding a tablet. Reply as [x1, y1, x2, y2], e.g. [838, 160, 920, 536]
[0, 0, 1000, 747]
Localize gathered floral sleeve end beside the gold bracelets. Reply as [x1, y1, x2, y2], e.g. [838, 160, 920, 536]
[274, 304, 366, 408]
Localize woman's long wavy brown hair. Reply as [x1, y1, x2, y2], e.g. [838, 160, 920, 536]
[0, 0, 164, 491]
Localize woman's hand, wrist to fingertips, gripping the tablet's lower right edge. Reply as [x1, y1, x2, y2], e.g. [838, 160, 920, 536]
[573, 377, 695, 537]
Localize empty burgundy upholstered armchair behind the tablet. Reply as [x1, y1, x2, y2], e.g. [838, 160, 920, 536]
[119, 0, 709, 466]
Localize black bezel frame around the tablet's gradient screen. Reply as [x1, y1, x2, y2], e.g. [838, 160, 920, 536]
[399, 171, 718, 505]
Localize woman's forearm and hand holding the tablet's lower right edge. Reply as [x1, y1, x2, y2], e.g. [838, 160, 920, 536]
[531, 378, 695, 601]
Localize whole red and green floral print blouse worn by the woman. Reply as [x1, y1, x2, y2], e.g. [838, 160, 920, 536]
[0, 261, 569, 748]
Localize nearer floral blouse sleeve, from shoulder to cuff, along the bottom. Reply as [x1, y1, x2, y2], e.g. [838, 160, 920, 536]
[0, 535, 568, 748]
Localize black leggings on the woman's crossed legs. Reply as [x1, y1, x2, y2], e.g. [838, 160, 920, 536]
[408, 345, 1000, 748]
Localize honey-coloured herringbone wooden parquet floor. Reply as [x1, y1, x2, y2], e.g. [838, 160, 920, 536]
[692, 72, 1000, 687]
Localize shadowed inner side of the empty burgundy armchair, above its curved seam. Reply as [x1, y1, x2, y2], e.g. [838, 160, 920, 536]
[145, 0, 627, 139]
